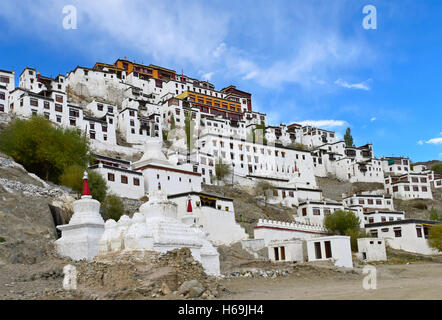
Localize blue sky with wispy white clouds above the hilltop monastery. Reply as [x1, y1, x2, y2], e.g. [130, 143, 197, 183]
[0, 0, 442, 161]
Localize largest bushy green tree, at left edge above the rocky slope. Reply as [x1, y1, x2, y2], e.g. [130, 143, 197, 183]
[0, 116, 90, 183]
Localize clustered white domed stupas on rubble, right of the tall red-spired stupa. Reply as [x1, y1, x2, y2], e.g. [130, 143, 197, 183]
[100, 190, 220, 275]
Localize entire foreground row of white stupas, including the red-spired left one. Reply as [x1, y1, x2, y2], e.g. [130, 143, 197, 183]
[55, 173, 220, 275]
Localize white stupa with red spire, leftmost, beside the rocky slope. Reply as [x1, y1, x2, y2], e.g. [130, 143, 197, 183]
[55, 172, 104, 260]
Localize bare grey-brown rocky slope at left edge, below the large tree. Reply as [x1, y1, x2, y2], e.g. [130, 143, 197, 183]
[0, 154, 73, 265]
